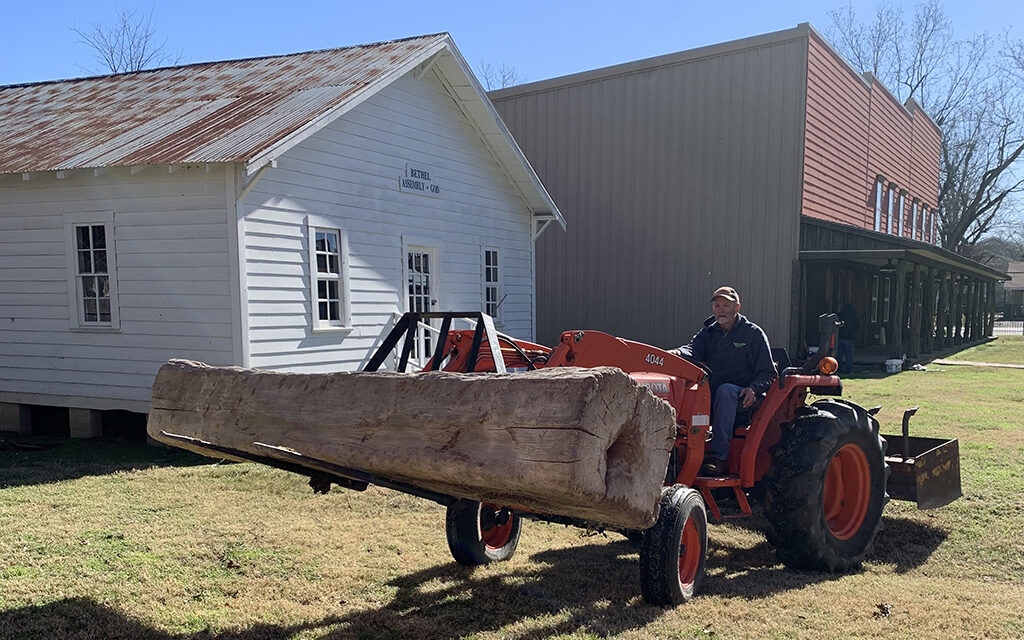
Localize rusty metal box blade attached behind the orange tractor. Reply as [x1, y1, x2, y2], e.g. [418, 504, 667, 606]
[882, 409, 963, 509]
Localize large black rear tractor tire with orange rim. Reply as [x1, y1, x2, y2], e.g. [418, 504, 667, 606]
[764, 399, 889, 571]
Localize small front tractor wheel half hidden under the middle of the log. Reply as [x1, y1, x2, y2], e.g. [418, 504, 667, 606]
[444, 500, 522, 566]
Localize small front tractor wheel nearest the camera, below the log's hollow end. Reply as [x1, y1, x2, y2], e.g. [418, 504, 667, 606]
[640, 484, 708, 605]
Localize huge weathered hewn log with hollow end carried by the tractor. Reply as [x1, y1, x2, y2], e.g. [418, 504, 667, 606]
[148, 360, 676, 528]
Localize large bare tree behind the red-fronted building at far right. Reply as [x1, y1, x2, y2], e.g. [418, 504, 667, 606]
[826, 0, 1024, 253]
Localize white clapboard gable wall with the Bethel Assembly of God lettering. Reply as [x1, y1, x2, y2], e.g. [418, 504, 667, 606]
[241, 66, 535, 372]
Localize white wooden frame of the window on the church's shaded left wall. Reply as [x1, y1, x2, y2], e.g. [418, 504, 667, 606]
[63, 211, 121, 332]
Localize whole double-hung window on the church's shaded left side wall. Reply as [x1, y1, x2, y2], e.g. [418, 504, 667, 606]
[65, 212, 121, 329]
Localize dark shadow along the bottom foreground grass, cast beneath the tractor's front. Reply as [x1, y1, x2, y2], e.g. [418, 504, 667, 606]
[0, 540, 851, 640]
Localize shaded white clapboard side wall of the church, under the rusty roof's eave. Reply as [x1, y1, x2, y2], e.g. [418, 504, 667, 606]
[0, 165, 234, 411]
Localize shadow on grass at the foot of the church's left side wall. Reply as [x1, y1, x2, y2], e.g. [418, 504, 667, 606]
[0, 433, 211, 488]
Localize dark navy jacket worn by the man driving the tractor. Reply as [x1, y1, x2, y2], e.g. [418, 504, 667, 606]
[680, 314, 778, 395]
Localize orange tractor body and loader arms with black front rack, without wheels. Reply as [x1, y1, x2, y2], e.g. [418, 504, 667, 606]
[411, 312, 843, 521]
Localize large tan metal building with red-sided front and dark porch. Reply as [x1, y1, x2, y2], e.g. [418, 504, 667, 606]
[489, 24, 1006, 356]
